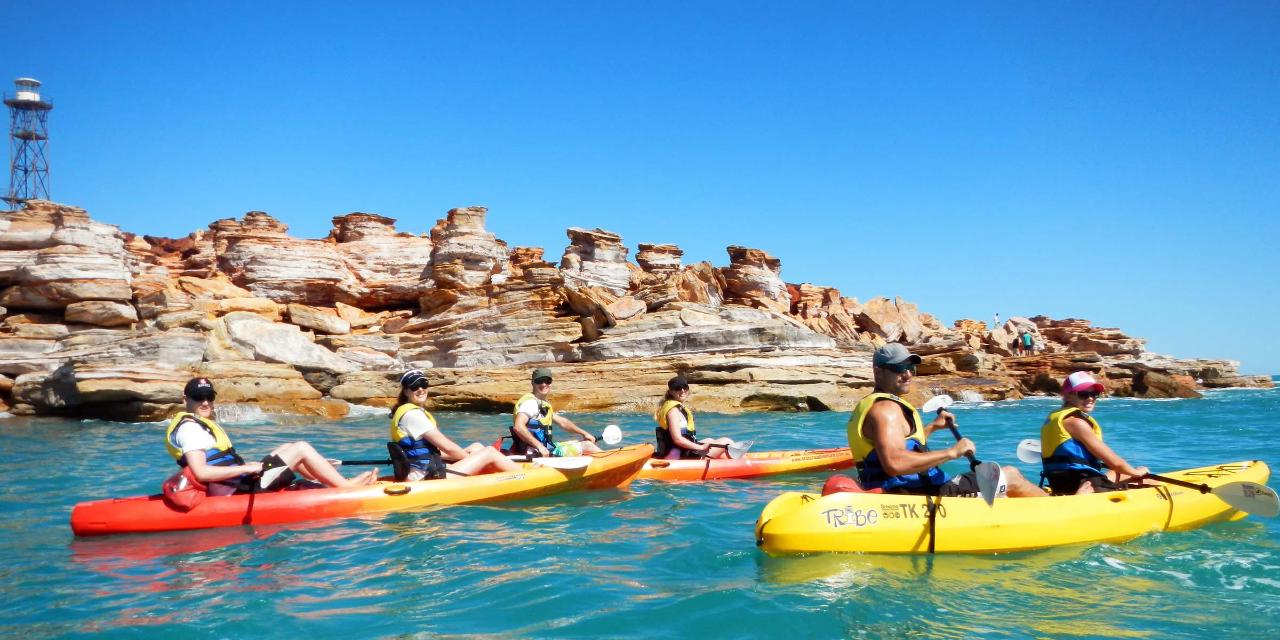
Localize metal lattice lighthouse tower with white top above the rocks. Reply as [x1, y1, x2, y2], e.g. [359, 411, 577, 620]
[4, 78, 54, 205]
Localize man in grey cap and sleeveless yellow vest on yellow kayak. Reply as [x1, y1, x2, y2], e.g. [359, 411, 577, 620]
[847, 343, 1046, 498]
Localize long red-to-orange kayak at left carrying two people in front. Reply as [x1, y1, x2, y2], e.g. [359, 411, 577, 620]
[70, 444, 653, 535]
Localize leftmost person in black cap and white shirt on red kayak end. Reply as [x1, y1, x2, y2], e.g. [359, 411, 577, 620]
[165, 378, 378, 495]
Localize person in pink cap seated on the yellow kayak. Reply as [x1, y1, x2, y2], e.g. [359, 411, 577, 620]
[1041, 371, 1147, 495]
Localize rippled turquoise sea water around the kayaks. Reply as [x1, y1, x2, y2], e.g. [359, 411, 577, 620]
[0, 381, 1280, 639]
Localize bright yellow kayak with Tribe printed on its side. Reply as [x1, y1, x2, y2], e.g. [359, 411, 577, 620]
[755, 461, 1275, 554]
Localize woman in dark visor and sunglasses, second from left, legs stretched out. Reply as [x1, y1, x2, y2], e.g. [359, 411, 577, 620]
[392, 369, 521, 480]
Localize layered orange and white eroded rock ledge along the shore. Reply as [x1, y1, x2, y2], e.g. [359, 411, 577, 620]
[0, 201, 1271, 421]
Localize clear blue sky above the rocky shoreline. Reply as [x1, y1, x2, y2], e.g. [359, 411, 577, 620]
[0, 0, 1280, 372]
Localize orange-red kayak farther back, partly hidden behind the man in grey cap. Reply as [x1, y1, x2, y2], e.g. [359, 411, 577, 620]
[637, 447, 854, 480]
